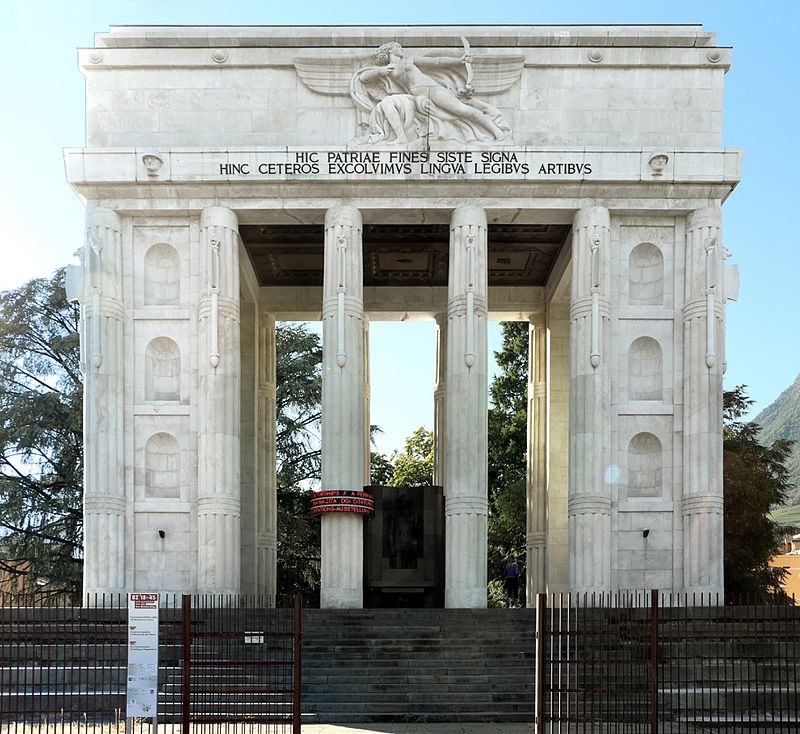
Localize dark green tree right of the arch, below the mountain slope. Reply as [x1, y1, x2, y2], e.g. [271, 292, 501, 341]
[723, 385, 794, 601]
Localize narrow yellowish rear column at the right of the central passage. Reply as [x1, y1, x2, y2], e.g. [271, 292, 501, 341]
[526, 312, 548, 606]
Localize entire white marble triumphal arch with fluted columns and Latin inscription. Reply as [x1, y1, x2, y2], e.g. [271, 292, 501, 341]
[66, 26, 741, 607]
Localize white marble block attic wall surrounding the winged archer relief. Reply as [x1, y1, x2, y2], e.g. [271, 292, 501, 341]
[80, 26, 730, 148]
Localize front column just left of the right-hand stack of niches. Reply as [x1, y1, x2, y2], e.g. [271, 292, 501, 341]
[568, 207, 613, 593]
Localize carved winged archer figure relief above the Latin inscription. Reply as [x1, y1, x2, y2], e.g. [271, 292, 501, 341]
[295, 38, 525, 145]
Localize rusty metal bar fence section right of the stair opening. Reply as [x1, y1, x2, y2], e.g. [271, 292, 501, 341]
[536, 592, 800, 734]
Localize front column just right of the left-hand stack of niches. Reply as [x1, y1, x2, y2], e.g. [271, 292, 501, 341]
[197, 207, 241, 594]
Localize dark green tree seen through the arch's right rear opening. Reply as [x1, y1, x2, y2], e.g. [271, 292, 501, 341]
[488, 321, 528, 606]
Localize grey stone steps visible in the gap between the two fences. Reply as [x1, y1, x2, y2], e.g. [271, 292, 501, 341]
[303, 609, 535, 723]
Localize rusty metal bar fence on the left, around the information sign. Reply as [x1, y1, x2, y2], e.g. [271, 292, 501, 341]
[0, 595, 302, 734]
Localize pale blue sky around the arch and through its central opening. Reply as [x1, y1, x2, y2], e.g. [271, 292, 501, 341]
[0, 0, 800, 458]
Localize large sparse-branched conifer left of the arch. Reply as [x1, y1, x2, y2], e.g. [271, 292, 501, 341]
[0, 270, 83, 594]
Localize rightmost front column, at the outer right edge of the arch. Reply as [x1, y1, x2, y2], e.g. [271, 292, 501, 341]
[681, 207, 724, 593]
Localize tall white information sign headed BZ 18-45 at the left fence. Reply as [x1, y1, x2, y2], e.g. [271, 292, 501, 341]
[127, 594, 158, 719]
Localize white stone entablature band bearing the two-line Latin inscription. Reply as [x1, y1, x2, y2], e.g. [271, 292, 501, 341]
[65, 146, 742, 211]
